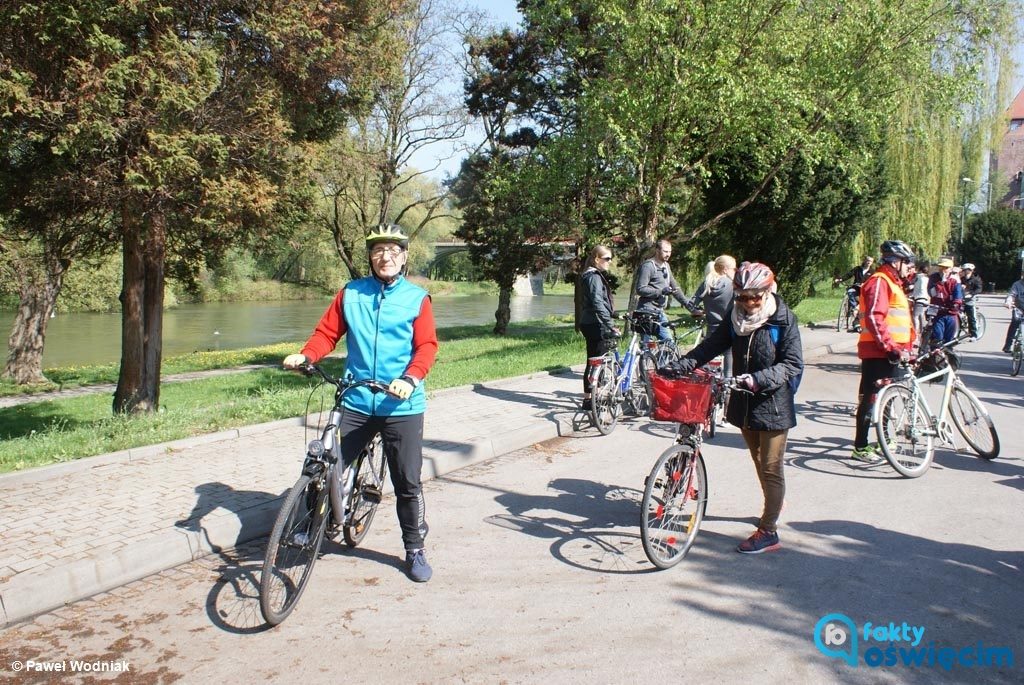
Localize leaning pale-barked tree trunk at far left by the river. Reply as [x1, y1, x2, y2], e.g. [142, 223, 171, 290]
[3, 264, 65, 385]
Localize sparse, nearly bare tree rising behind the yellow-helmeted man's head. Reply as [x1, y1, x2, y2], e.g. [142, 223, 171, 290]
[318, 0, 467, 277]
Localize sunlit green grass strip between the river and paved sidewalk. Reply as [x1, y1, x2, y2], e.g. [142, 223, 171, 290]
[0, 320, 584, 472]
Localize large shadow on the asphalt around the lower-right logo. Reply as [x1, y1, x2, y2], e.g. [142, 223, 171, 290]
[675, 520, 1024, 683]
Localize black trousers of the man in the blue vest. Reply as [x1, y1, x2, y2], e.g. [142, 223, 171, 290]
[340, 411, 427, 550]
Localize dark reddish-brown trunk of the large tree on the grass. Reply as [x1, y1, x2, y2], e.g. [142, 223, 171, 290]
[114, 209, 166, 414]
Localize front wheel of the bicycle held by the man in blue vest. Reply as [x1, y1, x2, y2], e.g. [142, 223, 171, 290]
[259, 475, 330, 626]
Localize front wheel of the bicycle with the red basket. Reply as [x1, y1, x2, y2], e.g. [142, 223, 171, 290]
[640, 444, 708, 569]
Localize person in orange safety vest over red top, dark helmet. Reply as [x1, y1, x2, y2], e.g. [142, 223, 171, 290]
[850, 241, 914, 464]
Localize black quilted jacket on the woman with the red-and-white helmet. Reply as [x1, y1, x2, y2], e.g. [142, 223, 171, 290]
[686, 295, 804, 430]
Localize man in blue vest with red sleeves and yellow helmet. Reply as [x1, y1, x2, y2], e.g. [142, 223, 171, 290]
[284, 225, 437, 583]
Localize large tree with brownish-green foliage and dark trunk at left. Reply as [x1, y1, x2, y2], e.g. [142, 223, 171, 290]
[0, 0, 399, 412]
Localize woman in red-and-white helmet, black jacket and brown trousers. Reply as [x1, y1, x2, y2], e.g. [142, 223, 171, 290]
[659, 262, 804, 554]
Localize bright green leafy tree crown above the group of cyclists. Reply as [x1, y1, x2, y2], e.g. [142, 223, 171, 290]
[460, 0, 995, 282]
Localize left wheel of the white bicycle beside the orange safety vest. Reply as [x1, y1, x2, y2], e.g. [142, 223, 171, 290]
[874, 385, 935, 478]
